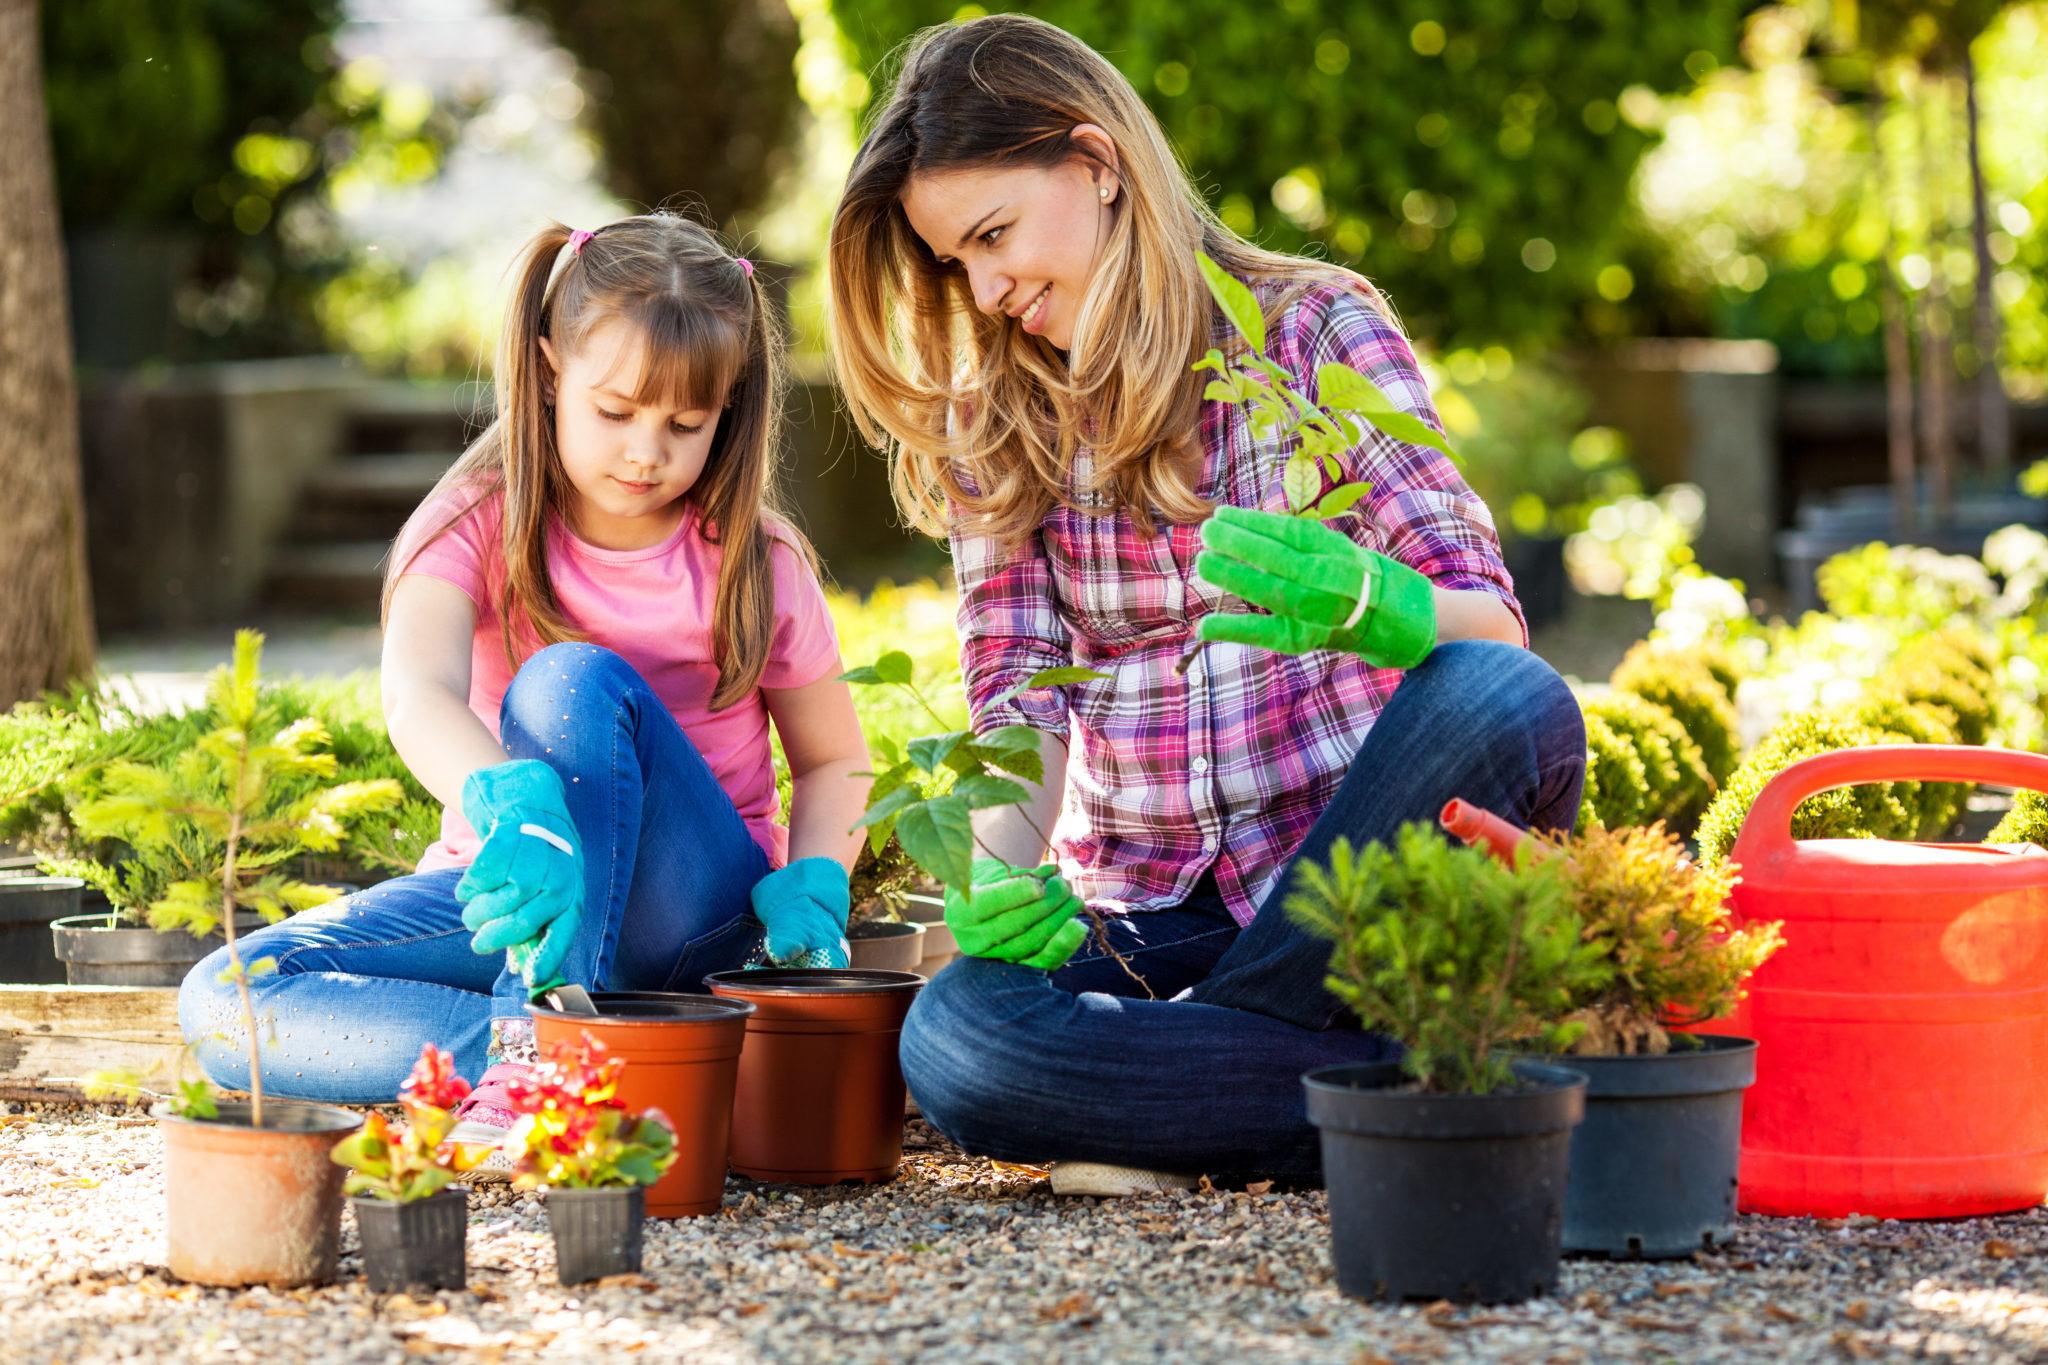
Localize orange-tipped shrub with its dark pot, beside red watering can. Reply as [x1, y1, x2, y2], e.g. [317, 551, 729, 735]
[1540, 825, 1784, 1257]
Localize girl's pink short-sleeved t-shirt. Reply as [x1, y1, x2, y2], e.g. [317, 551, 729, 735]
[399, 493, 844, 872]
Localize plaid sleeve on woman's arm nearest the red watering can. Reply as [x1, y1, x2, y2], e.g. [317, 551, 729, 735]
[1292, 287, 1528, 645]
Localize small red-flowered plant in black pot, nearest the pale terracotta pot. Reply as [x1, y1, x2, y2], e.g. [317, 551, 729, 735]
[332, 1044, 481, 1293]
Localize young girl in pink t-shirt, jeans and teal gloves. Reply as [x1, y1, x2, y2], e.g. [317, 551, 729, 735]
[180, 213, 866, 1142]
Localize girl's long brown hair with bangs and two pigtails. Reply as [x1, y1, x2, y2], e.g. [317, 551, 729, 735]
[383, 213, 817, 708]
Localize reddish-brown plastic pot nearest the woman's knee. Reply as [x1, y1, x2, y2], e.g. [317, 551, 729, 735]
[705, 968, 924, 1185]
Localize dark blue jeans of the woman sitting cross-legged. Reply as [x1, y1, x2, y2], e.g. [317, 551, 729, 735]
[903, 641, 1585, 1181]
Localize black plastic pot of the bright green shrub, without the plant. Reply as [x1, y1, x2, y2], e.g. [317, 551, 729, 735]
[1300, 1062, 1585, 1304]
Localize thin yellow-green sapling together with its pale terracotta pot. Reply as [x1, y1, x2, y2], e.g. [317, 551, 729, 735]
[82, 630, 379, 1285]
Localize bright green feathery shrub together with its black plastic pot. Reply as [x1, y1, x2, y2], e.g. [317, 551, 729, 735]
[1284, 825, 1610, 1304]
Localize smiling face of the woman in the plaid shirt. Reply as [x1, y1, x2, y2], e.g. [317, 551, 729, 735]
[903, 123, 1118, 350]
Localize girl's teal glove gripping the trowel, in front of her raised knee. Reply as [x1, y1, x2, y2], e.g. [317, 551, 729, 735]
[455, 759, 584, 990]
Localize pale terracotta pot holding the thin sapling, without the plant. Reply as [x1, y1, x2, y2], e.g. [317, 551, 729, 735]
[158, 1101, 362, 1287]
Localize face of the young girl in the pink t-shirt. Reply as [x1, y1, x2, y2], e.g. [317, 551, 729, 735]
[541, 317, 719, 551]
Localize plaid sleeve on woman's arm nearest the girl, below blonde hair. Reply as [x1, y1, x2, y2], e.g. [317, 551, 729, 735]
[950, 511, 1073, 739]
